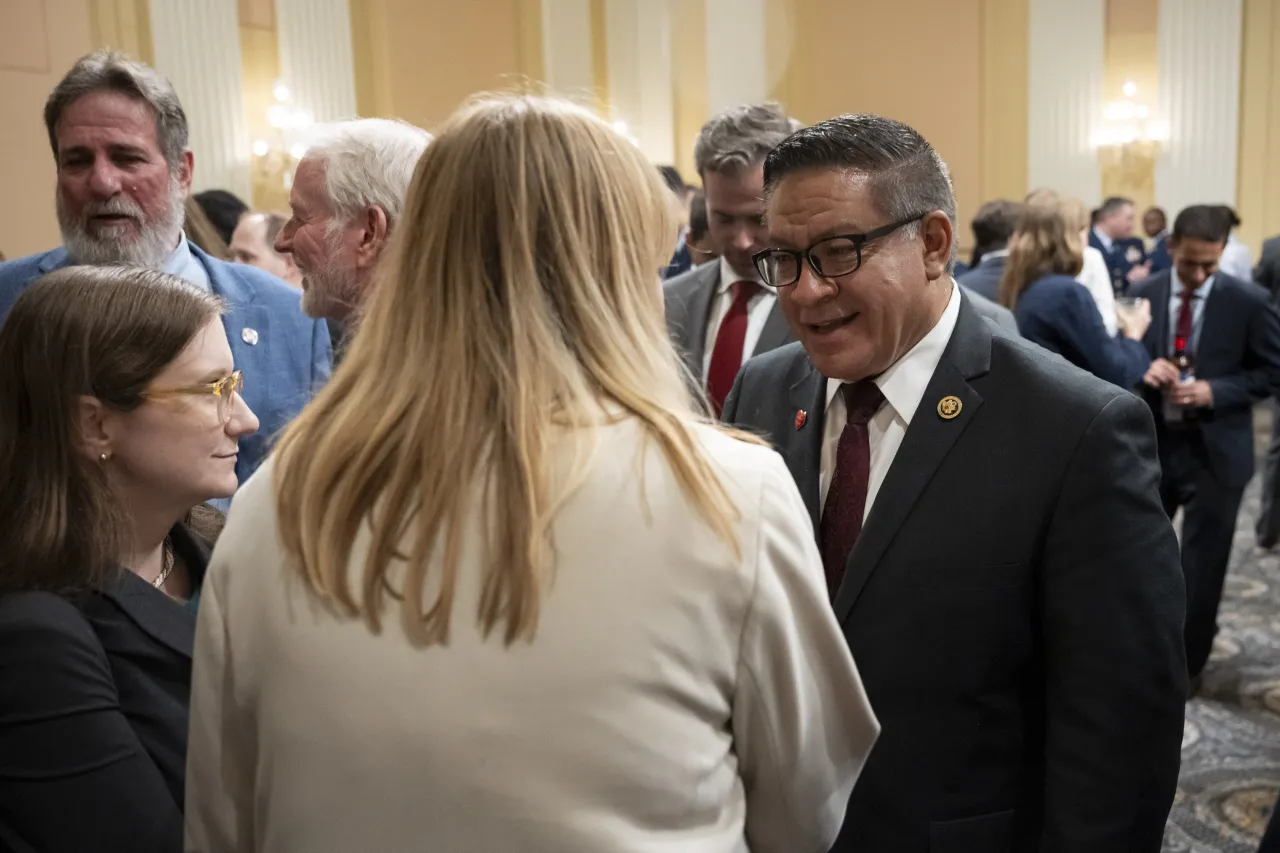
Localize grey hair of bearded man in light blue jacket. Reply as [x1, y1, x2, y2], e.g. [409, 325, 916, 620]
[45, 50, 187, 170]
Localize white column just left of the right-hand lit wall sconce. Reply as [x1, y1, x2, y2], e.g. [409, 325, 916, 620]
[1027, 0, 1106, 205]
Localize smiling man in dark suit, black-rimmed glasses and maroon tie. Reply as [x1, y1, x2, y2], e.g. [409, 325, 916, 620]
[724, 115, 1187, 853]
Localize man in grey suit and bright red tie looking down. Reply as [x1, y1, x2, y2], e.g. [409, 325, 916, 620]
[663, 104, 791, 414]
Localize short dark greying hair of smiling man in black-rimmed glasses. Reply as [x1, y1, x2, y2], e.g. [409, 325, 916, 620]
[764, 115, 956, 257]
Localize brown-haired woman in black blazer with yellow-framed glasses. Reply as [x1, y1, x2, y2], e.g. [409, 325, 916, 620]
[0, 266, 257, 853]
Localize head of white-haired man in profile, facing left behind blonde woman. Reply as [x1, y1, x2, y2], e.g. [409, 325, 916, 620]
[275, 119, 431, 327]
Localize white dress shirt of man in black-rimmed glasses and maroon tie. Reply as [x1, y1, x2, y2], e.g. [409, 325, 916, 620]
[819, 282, 960, 520]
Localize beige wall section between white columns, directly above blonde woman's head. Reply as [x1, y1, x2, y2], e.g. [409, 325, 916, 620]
[351, 0, 541, 129]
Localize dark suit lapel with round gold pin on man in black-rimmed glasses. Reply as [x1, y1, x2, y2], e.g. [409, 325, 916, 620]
[835, 298, 991, 621]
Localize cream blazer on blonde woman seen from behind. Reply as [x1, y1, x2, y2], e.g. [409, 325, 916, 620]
[186, 420, 878, 853]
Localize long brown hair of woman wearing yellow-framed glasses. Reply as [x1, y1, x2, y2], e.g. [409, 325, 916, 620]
[0, 266, 223, 592]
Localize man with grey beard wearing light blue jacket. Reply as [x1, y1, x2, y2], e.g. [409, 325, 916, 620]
[0, 51, 332, 482]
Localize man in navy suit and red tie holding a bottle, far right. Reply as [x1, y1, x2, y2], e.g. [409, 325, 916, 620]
[1133, 205, 1280, 679]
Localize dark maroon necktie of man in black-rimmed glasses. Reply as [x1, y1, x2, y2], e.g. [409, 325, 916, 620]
[819, 379, 884, 598]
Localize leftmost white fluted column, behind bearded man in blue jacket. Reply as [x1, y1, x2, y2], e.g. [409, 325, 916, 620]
[150, 0, 252, 195]
